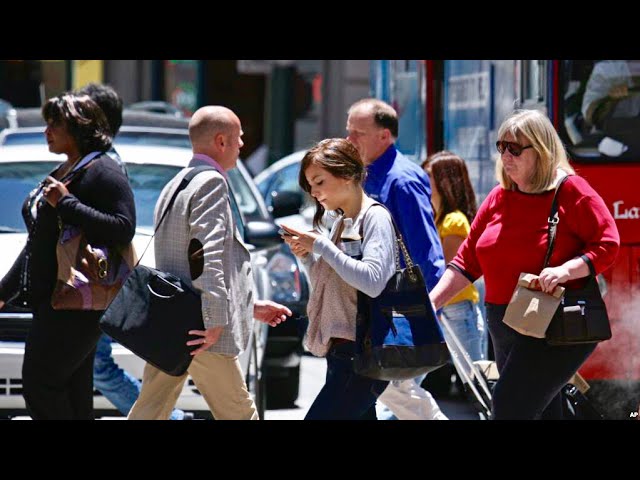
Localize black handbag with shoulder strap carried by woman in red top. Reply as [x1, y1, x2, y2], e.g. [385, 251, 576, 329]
[543, 176, 611, 345]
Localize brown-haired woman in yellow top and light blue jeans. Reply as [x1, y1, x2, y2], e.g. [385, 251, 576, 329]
[422, 150, 486, 361]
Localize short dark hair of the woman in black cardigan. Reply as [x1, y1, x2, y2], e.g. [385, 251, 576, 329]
[42, 94, 111, 156]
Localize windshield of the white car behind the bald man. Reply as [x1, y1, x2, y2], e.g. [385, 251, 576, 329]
[0, 162, 260, 233]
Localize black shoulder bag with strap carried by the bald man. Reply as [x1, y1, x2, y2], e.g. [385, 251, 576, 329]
[100, 167, 213, 376]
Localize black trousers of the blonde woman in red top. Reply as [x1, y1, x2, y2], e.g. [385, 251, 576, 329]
[486, 303, 596, 420]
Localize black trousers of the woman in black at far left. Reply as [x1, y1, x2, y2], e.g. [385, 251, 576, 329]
[22, 304, 103, 420]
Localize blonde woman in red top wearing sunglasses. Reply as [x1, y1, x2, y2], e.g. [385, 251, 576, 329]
[430, 110, 620, 420]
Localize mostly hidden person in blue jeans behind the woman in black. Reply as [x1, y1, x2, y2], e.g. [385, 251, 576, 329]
[74, 83, 193, 420]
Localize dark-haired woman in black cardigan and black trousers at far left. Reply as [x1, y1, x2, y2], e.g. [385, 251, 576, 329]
[0, 94, 136, 419]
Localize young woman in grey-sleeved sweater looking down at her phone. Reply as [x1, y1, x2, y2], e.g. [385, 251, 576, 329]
[282, 138, 396, 420]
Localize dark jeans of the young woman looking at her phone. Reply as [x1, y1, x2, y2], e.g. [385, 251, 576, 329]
[305, 342, 389, 420]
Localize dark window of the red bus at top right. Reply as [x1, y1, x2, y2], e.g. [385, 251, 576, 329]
[561, 60, 640, 161]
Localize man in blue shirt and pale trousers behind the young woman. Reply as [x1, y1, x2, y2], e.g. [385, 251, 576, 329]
[347, 98, 446, 420]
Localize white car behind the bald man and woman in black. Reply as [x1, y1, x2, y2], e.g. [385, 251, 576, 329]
[0, 126, 308, 418]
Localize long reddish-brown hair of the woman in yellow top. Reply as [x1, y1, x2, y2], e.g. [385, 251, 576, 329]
[422, 150, 478, 225]
